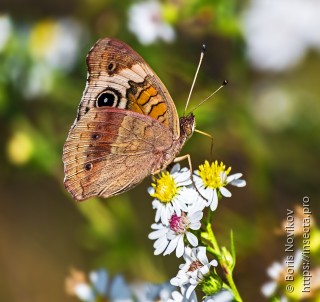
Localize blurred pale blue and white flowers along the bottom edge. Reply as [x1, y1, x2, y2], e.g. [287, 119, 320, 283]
[66, 269, 233, 302]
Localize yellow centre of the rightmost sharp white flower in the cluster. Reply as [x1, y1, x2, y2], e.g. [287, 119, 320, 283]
[199, 160, 231, 189]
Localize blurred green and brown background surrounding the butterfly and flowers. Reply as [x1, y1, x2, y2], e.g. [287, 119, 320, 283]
[0, 0, 320, 302]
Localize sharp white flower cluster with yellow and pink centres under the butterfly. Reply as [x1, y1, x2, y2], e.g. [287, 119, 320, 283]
[148, 161, 246, 301]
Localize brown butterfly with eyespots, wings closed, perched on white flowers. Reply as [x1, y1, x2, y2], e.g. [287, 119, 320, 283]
[63, 38, 195, 201]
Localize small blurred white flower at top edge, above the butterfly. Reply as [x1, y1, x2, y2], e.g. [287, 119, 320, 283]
[128, 1, 175, 44]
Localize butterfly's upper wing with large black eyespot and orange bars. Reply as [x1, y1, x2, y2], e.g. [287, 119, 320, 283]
[75, 38, 180, 139]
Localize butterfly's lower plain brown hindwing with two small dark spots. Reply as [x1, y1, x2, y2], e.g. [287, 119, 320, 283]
[63, 108, 172, 200]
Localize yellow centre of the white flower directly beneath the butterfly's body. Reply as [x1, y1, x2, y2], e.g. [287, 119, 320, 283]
[150, 172, 179, 203]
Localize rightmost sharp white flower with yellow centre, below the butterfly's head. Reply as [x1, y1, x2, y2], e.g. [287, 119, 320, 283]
[194, 161, 246, 211]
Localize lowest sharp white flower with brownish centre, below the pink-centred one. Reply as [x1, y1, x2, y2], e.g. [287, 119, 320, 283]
[170, 246, 218, 299]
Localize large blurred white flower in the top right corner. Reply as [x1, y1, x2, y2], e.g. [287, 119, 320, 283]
[243, 0, 320, 71]
